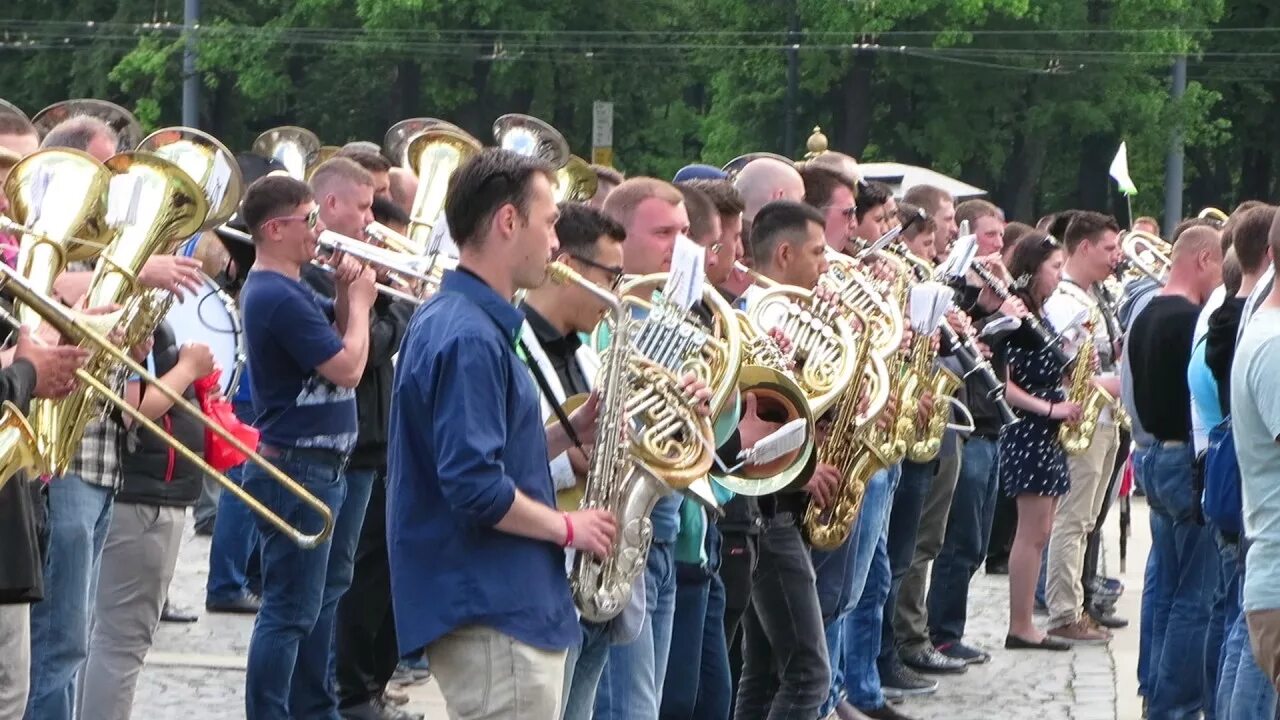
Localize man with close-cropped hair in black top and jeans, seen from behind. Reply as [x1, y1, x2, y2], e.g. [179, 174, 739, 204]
[1125, 227, 1218, 717]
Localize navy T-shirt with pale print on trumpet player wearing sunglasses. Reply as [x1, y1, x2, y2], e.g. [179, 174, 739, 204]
[239, 270, 356, 452]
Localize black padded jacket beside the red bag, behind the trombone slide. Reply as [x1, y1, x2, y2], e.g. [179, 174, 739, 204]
[115, 323, 205, 507]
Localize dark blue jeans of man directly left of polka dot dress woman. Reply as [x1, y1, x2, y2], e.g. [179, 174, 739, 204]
[928, 437, 1000, 644]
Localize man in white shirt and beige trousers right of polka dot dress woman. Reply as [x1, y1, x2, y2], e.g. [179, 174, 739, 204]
[1044, 211, 1123, 643]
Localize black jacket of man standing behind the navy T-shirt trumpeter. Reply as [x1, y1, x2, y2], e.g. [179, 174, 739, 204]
[302, 265, 413, 470]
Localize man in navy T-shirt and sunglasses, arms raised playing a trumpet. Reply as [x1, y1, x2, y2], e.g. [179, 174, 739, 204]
[241, 177, 376, 720]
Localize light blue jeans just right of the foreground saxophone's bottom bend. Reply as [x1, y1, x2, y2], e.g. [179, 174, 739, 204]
[595, 542, 676, 720]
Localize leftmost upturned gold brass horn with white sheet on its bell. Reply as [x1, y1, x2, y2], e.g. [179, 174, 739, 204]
[0, 147, 111, 325]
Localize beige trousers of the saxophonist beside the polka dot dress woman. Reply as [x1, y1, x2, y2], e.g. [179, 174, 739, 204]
[1044, 421, 1120, 628]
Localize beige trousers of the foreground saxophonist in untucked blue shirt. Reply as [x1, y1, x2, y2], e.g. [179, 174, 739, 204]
[426, 625, 566, 720]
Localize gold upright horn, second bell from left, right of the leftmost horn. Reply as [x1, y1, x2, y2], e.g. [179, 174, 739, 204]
[31, 151, 209, 475]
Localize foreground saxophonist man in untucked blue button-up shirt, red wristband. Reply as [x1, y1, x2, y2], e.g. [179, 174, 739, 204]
[384, 150, 616, 719]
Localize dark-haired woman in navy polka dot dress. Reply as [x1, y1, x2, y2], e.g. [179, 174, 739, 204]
[998, 231, 1080, 650]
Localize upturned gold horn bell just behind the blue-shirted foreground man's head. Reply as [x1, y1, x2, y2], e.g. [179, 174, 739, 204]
[404, 128, 483, 249]
